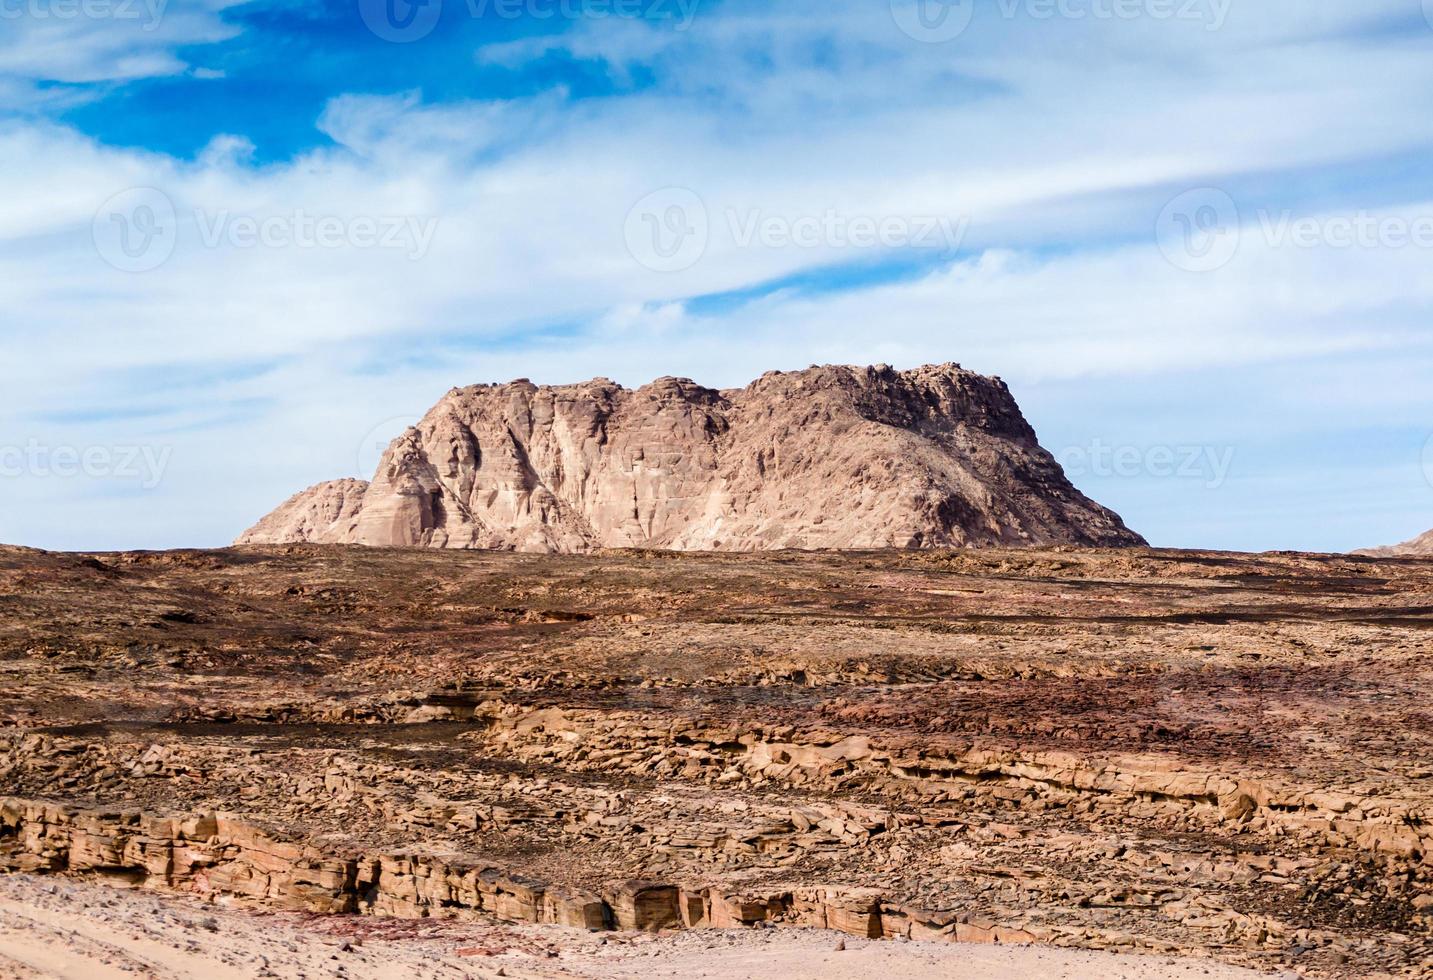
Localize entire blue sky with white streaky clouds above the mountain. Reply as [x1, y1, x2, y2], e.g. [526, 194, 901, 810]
[0, 0, 1433, 550]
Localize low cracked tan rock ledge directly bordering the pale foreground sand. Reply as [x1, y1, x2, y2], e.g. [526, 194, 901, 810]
[0, 797, 928, 943]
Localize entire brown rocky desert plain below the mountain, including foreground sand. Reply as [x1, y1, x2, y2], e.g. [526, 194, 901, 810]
[0, 546, 1433, 977]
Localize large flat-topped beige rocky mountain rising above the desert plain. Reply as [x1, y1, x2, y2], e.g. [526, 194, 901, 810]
[238, 364, 1144, 552]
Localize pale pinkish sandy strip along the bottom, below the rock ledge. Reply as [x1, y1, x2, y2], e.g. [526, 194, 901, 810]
[0, 875, 1289, 980]
